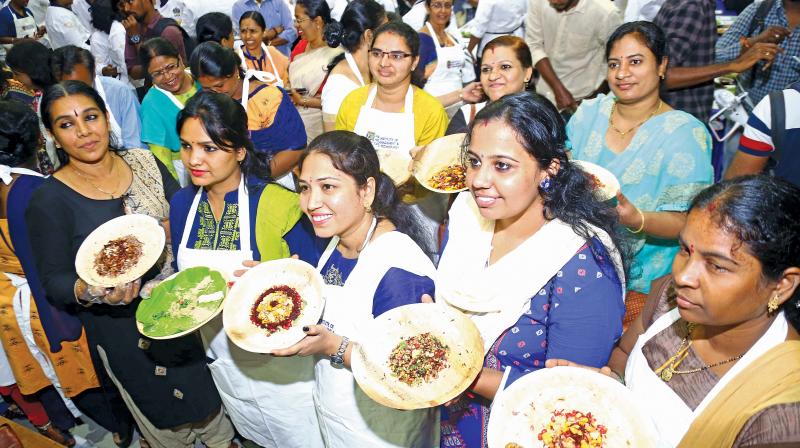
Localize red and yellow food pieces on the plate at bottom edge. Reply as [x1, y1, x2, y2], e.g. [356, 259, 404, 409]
[538, 409, 607, 448]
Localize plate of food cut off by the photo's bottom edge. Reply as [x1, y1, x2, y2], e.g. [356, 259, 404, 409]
[487, 367, 657, 448]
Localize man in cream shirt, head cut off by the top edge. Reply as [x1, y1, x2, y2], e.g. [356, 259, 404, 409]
[525, 0, 622, 112]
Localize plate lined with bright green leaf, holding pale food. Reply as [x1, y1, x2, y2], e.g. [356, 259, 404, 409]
[136, 266, 228, 339]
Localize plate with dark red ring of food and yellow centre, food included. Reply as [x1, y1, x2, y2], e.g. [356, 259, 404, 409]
[222, 258, 325, 353]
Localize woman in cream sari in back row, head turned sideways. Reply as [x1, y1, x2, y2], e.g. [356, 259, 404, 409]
[289, 0, 342, 142]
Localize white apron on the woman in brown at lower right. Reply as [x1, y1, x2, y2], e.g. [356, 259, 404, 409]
[625, 308, 789, 447]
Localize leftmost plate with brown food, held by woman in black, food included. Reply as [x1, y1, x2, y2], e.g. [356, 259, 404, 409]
[75, 215, 166, 288]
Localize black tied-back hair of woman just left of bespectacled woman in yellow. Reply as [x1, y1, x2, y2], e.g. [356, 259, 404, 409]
[325, 0, 386, 71]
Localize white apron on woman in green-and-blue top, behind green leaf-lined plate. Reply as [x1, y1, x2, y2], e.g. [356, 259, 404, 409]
[176, 178, 322, 448]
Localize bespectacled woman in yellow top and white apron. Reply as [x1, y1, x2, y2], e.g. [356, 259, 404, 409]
[336, 22, 448, 253]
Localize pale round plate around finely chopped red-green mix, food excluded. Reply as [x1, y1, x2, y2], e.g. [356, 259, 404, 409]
[351, 303, 483, 409]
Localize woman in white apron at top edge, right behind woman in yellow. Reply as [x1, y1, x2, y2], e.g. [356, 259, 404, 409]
[419, 0, 481, 116]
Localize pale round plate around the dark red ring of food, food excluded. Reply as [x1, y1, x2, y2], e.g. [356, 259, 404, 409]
[222, 258, 325, 353]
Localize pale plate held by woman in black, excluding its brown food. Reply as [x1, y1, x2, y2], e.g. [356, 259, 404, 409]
[75, 215, 166, 288]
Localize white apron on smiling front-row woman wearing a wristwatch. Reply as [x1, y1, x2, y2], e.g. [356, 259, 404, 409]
[314, 232, 439, 448]
